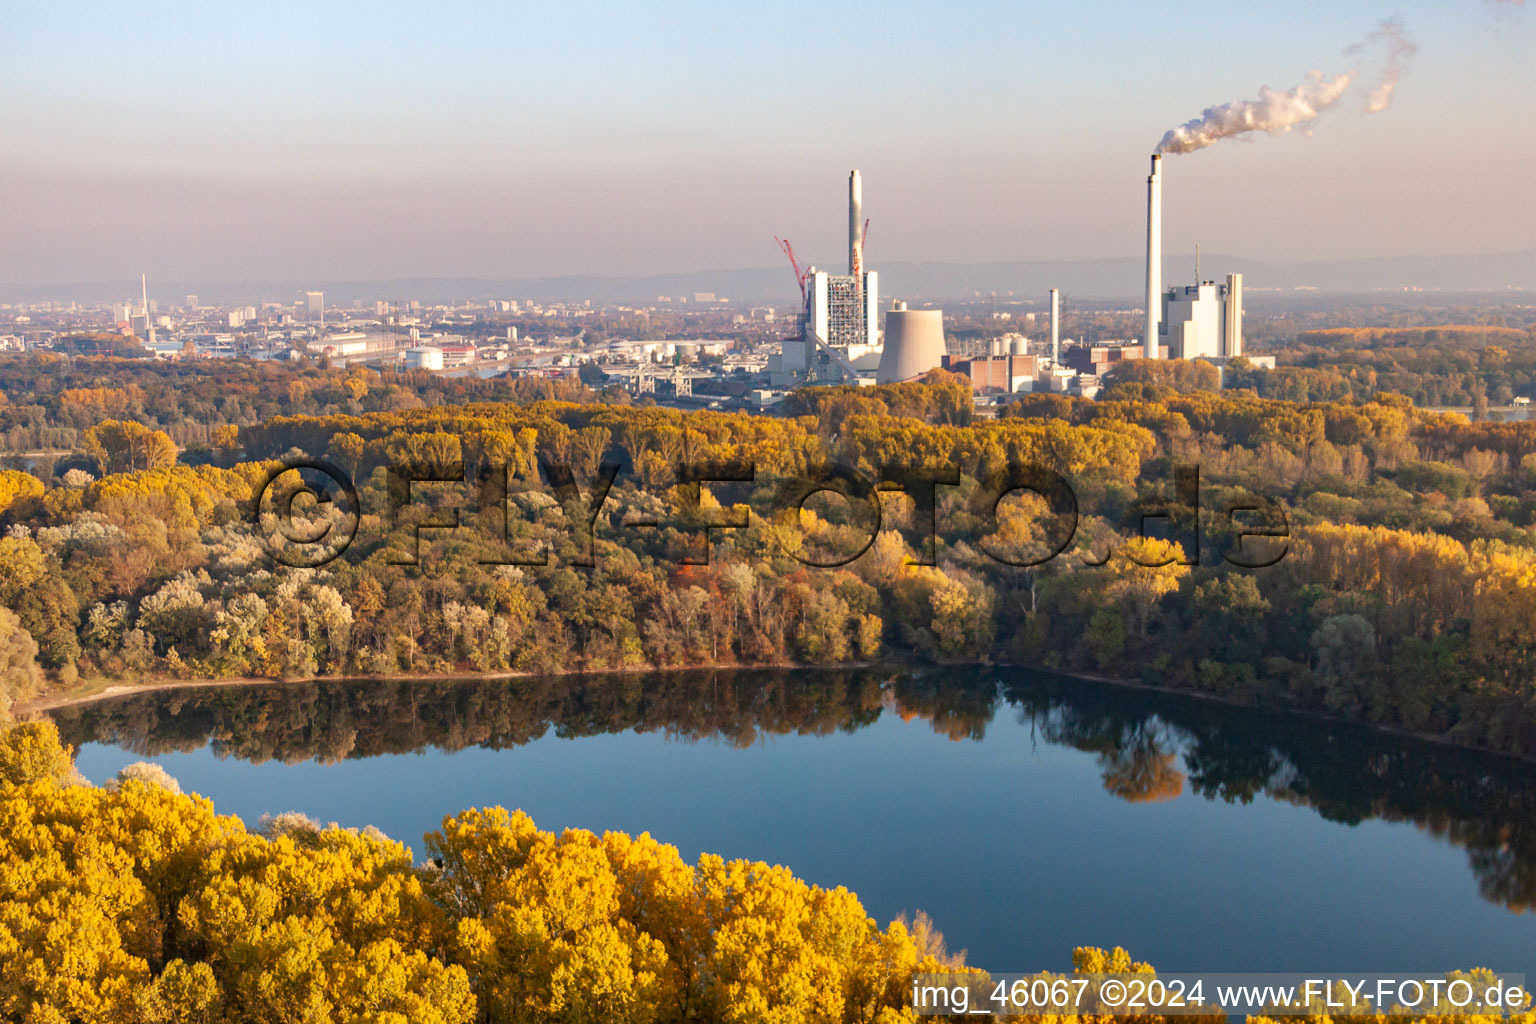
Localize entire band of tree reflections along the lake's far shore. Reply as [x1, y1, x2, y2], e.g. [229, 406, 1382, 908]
[44, 668, 1536, 910]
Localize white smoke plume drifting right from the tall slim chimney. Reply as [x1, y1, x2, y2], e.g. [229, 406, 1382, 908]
[1157, 17, 1419, 154]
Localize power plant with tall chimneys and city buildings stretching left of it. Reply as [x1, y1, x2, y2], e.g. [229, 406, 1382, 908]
[0, 155, 1272, 410]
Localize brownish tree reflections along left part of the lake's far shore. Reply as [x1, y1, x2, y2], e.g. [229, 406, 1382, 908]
[54, 671, 970, 763]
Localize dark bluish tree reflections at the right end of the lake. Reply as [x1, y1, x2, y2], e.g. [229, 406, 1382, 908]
[1003, 674, 1536, 912]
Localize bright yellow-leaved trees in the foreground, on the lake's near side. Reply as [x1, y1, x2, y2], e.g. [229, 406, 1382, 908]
[0, 723, 957, 1024]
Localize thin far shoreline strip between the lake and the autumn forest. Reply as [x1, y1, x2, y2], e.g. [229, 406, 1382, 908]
[11, 662, 1536, 765]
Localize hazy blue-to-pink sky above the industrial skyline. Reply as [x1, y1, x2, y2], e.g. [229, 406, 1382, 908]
[0, 0, 1536, 284]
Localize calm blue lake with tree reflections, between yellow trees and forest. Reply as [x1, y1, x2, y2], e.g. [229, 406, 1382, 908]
[54, 668, 1536, 975]
